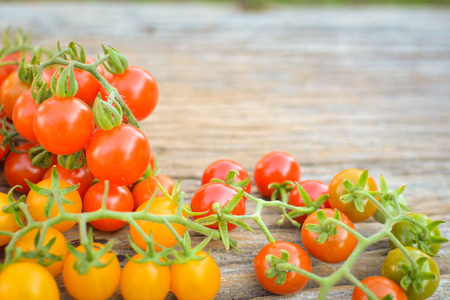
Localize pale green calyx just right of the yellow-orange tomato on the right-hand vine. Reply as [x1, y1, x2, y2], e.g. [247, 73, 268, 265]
[373, 175, 410, 224]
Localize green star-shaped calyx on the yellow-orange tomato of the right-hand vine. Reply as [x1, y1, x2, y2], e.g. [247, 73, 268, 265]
[340, 170, 381, 212]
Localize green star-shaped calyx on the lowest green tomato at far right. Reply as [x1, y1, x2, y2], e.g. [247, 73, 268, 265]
[397, 257, 437, 293]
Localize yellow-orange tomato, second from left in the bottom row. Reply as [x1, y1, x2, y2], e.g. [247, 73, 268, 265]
[63, 243, 120, 300]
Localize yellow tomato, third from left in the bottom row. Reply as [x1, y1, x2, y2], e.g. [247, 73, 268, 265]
[120, 254, 170, 300]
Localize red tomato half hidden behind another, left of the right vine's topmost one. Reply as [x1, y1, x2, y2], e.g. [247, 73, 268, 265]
[202, 159, 252, 194]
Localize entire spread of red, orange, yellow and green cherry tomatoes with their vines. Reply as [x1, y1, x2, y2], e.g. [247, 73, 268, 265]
[0, 29, 446, 299]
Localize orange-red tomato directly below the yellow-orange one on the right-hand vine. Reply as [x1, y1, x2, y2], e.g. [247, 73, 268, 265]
[302, 208, 358, 263]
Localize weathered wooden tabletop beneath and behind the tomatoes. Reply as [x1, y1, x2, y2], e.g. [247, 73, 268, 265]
[0, 3, 450, 299]
